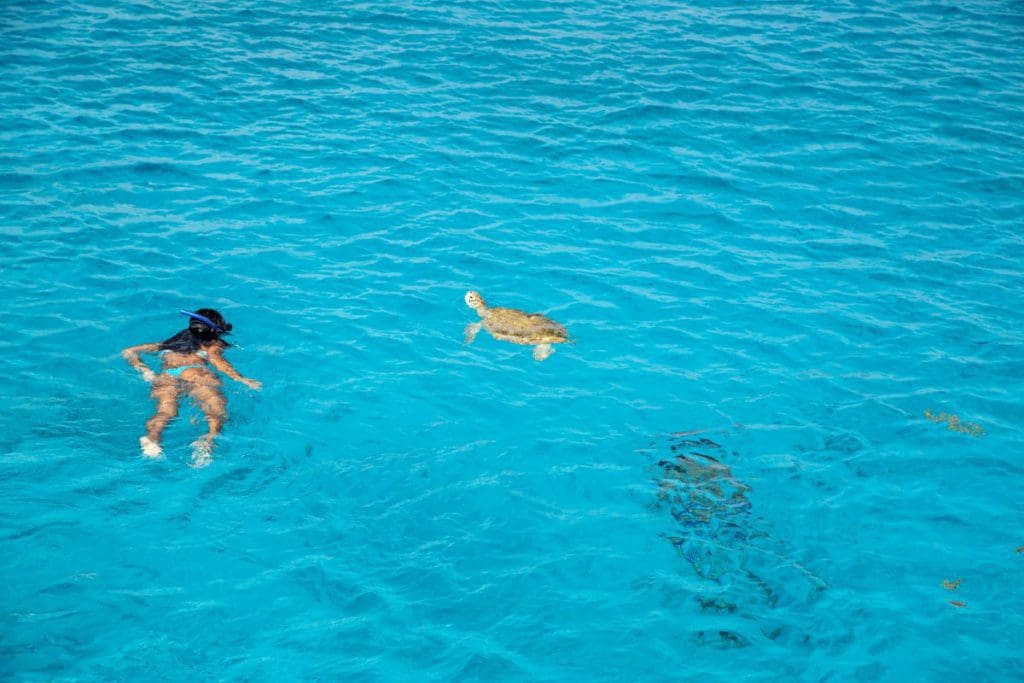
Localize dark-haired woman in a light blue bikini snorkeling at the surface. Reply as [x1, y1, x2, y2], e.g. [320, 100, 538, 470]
[121, 308, 262, 465]
